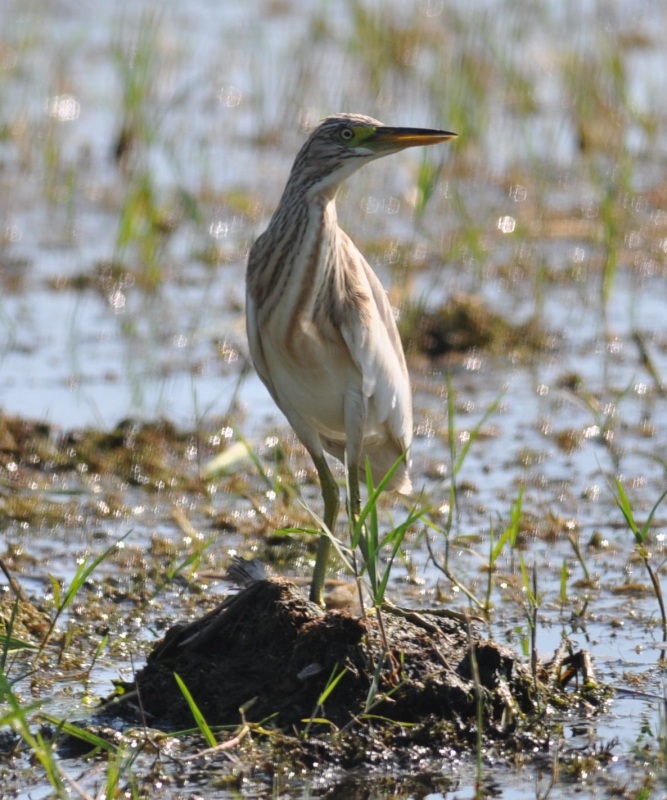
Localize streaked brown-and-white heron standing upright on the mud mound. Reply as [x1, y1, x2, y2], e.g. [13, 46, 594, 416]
[246, 113, 457, 606]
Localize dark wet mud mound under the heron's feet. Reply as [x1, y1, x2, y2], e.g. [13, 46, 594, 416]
[105, 579, 591, 740]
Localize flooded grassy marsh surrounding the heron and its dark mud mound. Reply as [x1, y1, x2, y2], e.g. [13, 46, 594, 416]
[0, 0, 667, 798]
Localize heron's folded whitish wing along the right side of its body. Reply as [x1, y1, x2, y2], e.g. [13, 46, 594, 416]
[340, 241, 412, 448]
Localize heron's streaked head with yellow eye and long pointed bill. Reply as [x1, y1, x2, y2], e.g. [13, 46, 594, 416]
[292, 114, 456, 197]
